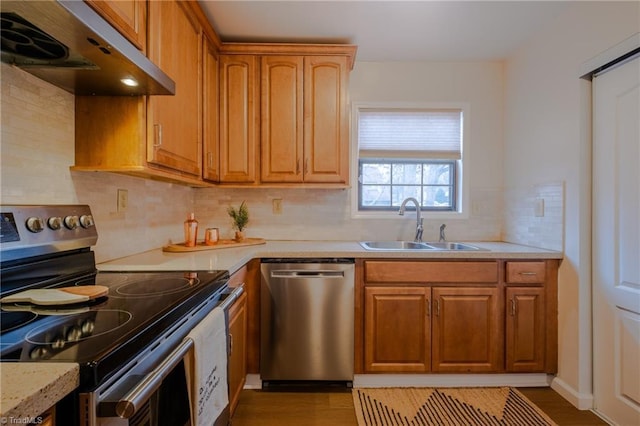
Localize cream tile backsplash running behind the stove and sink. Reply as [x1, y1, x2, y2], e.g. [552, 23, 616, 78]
[0, 63, 563, 262]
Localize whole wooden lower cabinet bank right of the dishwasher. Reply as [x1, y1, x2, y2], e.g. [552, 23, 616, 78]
[355, 259, 559, 374]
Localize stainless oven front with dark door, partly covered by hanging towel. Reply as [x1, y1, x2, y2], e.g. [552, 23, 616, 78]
[79, 286, 244, 426]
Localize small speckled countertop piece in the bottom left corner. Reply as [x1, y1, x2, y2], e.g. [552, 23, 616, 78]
[0, 362, 80, 424]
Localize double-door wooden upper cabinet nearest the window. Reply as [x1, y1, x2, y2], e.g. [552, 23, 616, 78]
[260, 56, 349, 184]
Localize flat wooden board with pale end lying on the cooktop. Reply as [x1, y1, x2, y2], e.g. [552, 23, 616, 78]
[0, 285, 109, 306]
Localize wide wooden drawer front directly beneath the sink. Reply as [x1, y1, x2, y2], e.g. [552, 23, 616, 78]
[365, 261, 498, 283]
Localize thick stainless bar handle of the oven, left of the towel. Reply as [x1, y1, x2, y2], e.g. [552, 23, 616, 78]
[116, 339, 193, 419]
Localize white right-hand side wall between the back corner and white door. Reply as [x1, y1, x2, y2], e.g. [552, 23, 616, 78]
[504, 2, 640, 408]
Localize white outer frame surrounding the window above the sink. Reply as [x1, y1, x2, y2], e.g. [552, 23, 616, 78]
[350, 101, 471, 219]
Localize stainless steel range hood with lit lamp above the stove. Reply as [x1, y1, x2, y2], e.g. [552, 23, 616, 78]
[0, 0, 175, 95]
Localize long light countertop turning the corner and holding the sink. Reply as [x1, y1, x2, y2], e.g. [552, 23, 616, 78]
[97, 240, 563, 273]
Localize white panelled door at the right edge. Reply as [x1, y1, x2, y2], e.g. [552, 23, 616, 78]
[592, 57, 640, 426]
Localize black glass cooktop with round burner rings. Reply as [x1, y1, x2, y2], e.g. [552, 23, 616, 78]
[0, 271, 229, 386]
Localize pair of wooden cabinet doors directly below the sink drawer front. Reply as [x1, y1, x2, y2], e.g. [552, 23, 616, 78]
[364, 286, 503, 373]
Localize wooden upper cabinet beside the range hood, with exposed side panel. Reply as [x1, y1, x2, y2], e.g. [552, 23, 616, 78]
[72, 1, 204, 186]
